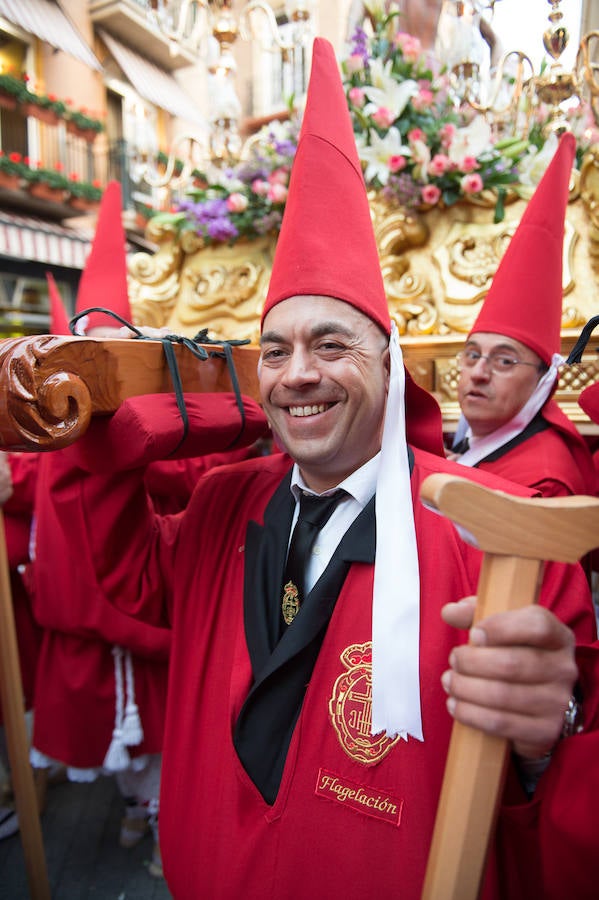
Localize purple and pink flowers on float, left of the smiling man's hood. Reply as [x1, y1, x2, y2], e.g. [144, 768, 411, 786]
[154, 117, 298, 245]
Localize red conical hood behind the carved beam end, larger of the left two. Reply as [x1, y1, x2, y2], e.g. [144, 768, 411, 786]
[76, 181, 131, 330]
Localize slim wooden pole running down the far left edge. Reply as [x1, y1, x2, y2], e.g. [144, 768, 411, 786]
[0, 510, 50, 900]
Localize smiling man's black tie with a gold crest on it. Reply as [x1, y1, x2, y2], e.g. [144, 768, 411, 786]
[281, 490, 347, 625]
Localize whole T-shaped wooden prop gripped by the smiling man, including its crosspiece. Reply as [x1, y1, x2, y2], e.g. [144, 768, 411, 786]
[421, 474, 599, 900]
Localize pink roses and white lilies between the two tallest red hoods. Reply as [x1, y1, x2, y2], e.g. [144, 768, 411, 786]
[342, 2, 528, 215]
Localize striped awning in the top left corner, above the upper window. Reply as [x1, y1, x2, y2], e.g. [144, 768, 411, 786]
[0, 0, 102, 72]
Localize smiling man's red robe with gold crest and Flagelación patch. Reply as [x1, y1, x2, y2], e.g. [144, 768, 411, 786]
[39, 412, 597, 900]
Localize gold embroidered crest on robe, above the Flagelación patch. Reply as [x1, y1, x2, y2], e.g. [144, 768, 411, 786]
[329, 641, 400, 765]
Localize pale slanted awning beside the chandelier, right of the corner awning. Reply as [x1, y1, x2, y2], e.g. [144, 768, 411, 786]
[101, 29, 206, 127]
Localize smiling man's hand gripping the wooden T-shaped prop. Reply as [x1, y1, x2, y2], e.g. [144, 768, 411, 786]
[441, 597, 578, 759]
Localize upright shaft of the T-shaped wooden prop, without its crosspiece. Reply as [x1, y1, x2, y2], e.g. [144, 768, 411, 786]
[422, 553, 543, 900]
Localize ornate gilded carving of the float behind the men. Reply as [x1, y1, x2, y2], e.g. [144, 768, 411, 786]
[129, 158, 599, 426]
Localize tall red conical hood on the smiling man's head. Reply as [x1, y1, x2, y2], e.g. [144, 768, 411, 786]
[262, 38, 391, 334]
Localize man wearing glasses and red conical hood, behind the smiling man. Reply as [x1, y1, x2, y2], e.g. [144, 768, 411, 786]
[449, 135, 596, 497]
